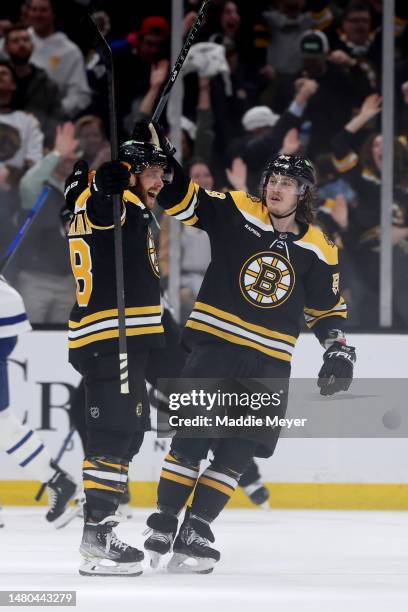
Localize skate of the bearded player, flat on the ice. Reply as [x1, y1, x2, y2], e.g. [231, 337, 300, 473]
[79, 515, 144, 576]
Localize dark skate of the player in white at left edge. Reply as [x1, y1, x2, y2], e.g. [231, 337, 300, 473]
[45, 465, 82, 529]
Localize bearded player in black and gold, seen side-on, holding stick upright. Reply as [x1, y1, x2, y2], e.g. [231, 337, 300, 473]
[65, 126, 171, 576]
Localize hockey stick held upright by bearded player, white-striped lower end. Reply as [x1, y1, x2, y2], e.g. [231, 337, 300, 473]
[82, 13, 129, 394]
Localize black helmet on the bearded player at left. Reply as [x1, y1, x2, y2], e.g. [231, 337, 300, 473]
[119, 140, 173, 183]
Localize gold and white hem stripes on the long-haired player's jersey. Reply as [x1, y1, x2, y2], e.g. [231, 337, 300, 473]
[186, 302, 296, 361]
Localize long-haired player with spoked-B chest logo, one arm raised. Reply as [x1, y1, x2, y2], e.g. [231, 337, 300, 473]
[145, 126, 355, 573]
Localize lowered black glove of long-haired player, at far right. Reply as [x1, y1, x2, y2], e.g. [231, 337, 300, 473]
[317, 342, 356, 395]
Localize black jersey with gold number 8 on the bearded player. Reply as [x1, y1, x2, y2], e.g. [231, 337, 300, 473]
[68, 182, 164, 364]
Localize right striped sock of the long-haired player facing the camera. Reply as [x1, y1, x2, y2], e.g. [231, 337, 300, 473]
[191, 466, 241, 522]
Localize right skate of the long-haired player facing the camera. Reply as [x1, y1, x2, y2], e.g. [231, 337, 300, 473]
[167, 514, 221, 574]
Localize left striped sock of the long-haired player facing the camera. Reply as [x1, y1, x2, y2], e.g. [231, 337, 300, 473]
[157, 451, 199, 515]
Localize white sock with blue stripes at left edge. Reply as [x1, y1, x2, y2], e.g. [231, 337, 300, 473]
[0, 408, 55, 482]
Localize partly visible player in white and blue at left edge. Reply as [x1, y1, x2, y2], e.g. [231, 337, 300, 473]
[0, 276, 77, 528]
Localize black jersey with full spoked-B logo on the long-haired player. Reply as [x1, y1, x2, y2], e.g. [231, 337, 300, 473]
[158, 162, 347, 362]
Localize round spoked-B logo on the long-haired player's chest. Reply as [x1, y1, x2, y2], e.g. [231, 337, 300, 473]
[239, 251, 295, 308]
